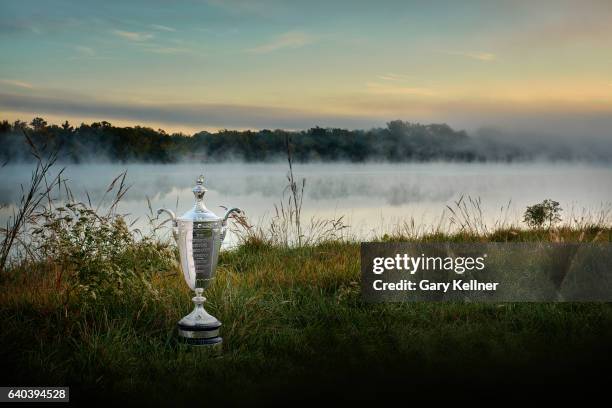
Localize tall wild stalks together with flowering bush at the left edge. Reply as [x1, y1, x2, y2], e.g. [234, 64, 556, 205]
[0, 135, 177, 316]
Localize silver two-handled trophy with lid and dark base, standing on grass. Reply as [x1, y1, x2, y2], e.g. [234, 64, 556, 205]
[157, 176, 241, 346]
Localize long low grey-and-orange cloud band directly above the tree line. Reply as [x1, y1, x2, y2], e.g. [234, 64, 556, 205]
[0, 87, 612, 140]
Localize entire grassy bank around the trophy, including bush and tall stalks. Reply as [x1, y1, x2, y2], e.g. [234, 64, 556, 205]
[0, 148, 612, 405]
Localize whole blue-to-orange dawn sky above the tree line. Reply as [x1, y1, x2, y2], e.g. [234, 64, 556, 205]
[0, 0, 612, 135]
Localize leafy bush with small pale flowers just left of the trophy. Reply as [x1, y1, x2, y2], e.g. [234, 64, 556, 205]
[33, 203, 176, 301]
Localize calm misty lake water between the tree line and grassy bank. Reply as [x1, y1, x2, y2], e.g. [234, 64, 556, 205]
[0, 163, 612, 245]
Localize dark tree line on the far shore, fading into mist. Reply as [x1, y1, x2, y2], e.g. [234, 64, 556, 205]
[0, 118, 600, 163]
